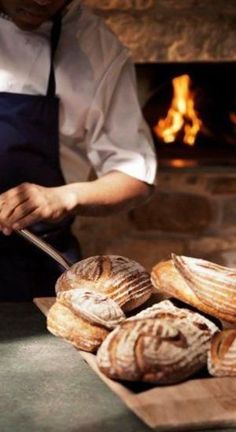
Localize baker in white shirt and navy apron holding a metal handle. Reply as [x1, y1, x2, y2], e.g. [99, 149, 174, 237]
[0, 0, 156, 301]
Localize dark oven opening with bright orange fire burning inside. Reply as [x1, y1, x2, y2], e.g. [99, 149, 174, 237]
[136, 62, 236, 168]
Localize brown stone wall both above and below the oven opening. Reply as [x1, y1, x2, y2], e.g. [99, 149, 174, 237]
[74, 0, 236, 270]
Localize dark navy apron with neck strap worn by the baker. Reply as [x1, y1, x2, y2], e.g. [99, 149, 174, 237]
[0, 15, 81, 301]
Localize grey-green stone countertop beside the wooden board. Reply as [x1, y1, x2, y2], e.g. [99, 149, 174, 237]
[0, 303, 235, 432]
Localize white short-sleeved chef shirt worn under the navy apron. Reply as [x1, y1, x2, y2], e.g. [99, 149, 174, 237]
[0, 0, 156, 183]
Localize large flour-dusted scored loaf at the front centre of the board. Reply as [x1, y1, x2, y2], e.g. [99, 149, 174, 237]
[97, 301, 218, 384]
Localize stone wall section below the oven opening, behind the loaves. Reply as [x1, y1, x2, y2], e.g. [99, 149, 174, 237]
[74, 168, 236, 270]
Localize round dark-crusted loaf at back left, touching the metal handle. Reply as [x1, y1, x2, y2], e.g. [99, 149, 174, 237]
[56, 255, 152, 312]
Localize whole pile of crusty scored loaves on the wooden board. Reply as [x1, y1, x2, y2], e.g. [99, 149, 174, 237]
[47, 255, 236, 385]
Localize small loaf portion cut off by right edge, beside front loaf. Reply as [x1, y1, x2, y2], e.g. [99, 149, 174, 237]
[208, 329, 236, 377]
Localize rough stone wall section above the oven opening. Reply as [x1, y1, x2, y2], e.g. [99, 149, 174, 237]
[84, 0, 236, 63]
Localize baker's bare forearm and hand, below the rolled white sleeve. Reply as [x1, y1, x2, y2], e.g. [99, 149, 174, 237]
[0, 171, 153, 234]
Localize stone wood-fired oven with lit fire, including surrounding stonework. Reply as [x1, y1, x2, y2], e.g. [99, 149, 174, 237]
[80, 0, 236, 269]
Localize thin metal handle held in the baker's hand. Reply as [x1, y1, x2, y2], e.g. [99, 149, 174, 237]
[16, 229, 71, 270]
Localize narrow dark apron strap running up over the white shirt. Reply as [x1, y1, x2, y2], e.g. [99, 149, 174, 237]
[47, 11, 62, 96]
